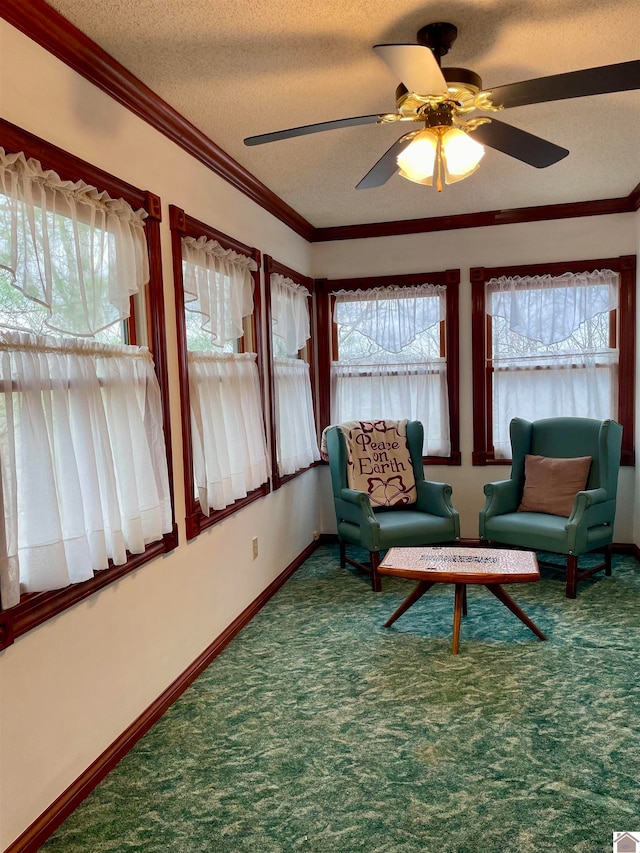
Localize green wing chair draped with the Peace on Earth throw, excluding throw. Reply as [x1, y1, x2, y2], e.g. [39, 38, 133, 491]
[326, 421, 460, 592]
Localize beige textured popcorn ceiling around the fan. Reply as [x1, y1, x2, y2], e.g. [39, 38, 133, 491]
[49, 0, 640, 227]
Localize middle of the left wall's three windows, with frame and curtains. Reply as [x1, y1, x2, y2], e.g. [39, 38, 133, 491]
[170, 205, 270, 539]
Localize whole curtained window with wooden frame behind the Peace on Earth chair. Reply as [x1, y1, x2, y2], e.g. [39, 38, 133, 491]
[319, 270, 460, 464]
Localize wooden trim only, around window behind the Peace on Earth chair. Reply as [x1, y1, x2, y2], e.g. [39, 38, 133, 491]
[315, 269, 462, 465]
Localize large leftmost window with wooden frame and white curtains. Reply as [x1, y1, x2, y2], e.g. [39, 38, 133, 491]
[0, 122, 176, 644]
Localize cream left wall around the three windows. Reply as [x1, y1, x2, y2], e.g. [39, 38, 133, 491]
[0, 20, 320, 850]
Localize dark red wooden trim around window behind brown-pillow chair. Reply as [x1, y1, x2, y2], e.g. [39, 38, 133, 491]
[470, 255, 636, 465]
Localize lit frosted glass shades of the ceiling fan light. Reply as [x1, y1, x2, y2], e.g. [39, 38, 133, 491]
[397, 127, 484, 192]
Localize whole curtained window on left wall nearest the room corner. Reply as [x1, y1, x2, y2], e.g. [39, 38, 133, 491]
[265, 255, 320, 488]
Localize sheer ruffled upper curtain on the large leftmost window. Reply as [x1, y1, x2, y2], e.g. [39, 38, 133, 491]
[0, 148, 149, 336]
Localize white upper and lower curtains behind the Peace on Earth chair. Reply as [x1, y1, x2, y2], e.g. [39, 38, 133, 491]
[331, 284, 451, 456]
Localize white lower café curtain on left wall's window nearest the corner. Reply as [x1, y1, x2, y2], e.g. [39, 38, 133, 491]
[274, 358, 320, 476]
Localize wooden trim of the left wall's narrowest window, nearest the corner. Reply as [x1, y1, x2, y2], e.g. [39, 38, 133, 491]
[264, 255, 319, 491]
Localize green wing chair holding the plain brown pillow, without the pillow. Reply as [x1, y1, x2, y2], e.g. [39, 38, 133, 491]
[480, 417, 622, 598]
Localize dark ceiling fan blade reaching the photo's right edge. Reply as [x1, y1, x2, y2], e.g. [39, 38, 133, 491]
[490, 59, 640, 109]
